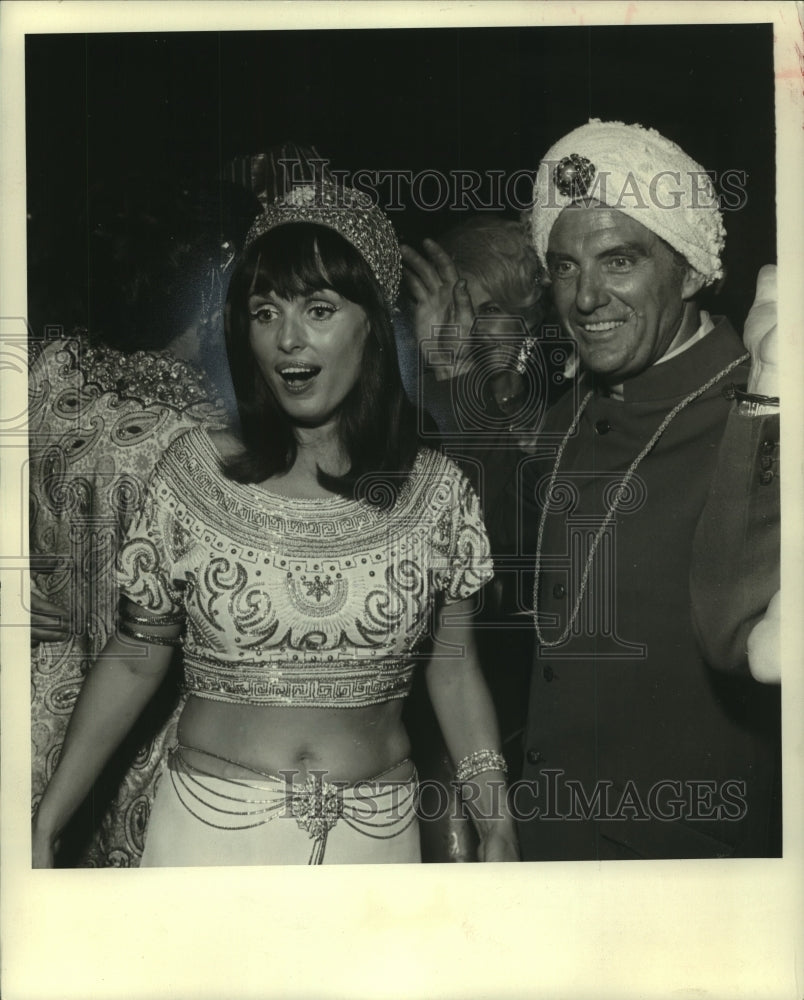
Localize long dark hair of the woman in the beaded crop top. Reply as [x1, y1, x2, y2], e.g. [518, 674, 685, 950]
[225, 222, 418, 505]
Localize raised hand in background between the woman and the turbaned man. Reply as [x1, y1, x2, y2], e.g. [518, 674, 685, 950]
[402, 240, 475, 381]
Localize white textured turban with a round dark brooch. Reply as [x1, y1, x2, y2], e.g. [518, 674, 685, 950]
[531, 118, 726, 284]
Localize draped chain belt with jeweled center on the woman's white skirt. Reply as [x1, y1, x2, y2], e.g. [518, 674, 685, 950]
[168, 744, 418, 865]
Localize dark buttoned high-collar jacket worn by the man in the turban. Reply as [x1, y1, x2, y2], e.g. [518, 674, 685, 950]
[506, 320, 779, 860]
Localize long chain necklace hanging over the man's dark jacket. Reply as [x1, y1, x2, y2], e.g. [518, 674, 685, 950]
[533, 353, 749, 647]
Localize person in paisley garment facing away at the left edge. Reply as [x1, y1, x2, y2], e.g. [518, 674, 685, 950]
[28, 177, 254, 867]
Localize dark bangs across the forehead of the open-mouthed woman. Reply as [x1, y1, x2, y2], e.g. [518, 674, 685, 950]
[245, 222, 379, 305]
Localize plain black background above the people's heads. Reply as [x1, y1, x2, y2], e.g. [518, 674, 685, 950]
[26, 24, 776, 333]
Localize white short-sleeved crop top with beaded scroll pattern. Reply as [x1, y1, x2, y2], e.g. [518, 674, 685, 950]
[112, 428, 492, 708]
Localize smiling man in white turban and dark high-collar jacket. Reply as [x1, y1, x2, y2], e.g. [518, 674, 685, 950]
[515, 121, 781, 860]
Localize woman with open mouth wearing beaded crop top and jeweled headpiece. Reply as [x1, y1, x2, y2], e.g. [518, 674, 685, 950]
[33, 184, 517, 866]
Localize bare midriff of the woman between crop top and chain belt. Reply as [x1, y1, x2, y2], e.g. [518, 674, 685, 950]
[178, 697, 412, 782]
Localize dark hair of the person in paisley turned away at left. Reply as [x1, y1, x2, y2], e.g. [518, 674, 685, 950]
[88, 178, 259, 352]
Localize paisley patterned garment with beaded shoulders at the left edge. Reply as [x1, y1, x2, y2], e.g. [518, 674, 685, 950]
[28, 337, 223, 867]
